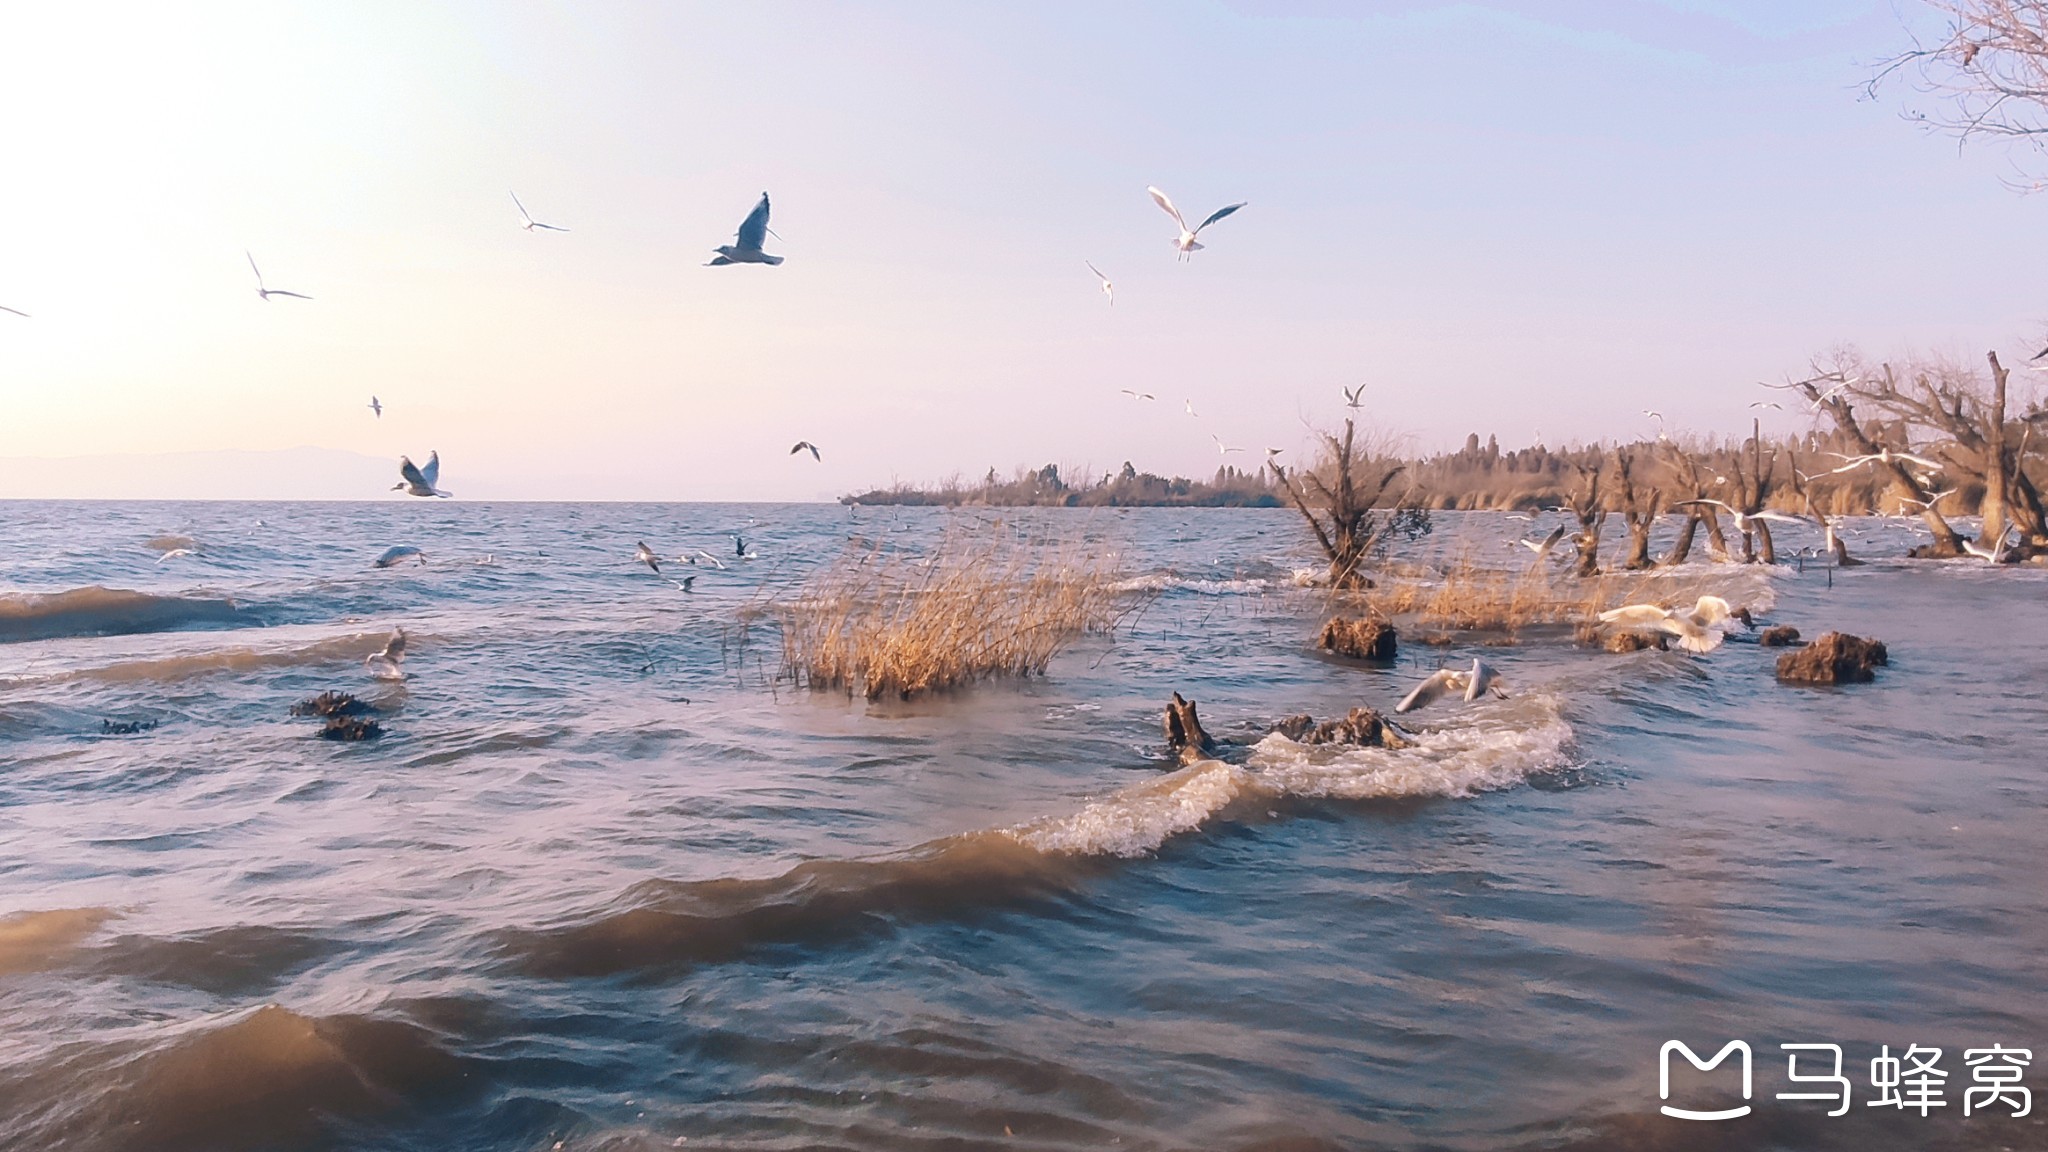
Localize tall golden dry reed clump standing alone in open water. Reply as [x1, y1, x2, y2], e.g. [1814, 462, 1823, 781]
[772, 535, 1147, 699]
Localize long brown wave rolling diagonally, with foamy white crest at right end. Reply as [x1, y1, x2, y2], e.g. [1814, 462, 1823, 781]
[504, 697, 1571, 976]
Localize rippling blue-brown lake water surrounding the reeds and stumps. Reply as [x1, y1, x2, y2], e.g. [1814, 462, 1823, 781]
[0, 500, 2048, 1152]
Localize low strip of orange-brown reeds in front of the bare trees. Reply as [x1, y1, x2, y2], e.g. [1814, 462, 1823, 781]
[1362, 558, 1747, 633]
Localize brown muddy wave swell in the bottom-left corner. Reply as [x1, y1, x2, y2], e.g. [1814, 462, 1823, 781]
[0, 1004, 465, 1152]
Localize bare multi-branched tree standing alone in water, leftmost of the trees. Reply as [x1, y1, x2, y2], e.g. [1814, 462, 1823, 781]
[1266, 420, 1430, 588]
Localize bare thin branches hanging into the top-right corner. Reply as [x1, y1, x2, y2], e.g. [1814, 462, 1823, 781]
[1866, 0, 2048, 191]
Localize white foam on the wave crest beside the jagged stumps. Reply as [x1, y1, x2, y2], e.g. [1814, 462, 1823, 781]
[1004, 695, 1571, 857]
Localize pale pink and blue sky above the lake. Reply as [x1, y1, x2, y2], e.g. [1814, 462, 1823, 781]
[0, 0, 2048, 500]
